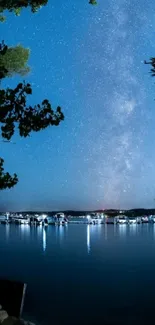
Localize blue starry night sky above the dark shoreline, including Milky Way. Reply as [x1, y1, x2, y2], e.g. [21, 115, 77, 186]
[0, 0, 155, 211]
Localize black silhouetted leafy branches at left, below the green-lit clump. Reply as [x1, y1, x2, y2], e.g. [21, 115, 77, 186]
[0, 83, 64, 190]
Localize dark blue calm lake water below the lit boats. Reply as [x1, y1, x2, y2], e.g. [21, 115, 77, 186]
[0, 224, 155, 325]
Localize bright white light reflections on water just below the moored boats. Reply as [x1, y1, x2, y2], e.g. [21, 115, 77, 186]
[1, 224, 155, 254]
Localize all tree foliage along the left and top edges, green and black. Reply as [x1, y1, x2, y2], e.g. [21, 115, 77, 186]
[0, 0, 97, 190]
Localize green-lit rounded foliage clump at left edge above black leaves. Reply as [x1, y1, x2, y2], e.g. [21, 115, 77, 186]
[0, 43, 30, 77]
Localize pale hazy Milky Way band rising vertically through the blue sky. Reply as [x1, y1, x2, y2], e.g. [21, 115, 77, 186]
[86, 1, 147, 207]
